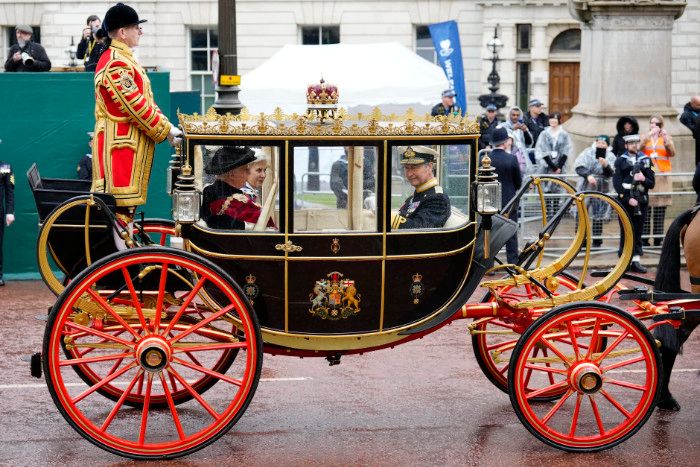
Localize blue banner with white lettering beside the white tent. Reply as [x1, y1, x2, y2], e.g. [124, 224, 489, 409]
[428, 20, 467, 115]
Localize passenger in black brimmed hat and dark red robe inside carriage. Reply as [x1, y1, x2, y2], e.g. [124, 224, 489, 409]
[200, 146, 275, 230]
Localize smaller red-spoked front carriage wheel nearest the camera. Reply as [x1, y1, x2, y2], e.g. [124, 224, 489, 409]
[508, 302, 660, 452]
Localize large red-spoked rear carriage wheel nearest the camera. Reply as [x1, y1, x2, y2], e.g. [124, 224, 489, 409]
[43, 247, 262, 459]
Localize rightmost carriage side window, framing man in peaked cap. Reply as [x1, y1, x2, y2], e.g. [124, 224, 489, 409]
[391, 144, 471, 230]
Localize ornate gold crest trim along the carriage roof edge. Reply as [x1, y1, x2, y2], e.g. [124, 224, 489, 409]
[177, 107, 479, 136]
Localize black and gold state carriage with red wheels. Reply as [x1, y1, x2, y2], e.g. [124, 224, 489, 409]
[29, 96, 696, 458]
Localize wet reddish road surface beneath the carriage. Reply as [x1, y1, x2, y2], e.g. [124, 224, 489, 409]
[0, 281, 700, 466]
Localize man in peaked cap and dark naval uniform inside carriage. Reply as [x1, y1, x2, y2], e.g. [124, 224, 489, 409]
[391, 146, 451, 230]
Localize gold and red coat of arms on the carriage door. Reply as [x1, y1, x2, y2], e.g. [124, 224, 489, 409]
[309, 271, 360, 320]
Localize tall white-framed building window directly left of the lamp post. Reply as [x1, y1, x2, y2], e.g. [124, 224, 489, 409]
[190, 27, 219, 113]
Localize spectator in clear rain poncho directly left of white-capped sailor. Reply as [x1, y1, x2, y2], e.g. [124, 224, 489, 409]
[574, 135, 615, 247]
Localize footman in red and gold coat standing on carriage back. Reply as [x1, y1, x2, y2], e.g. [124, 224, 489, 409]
[92, 3, 182, 227]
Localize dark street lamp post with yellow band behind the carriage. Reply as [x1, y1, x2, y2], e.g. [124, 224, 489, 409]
[213, 0, 243, 115]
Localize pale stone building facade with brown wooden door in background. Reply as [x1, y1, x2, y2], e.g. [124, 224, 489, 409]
[0, 0, 700, 115]
